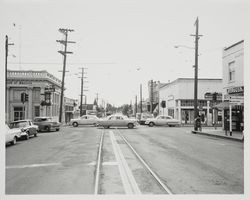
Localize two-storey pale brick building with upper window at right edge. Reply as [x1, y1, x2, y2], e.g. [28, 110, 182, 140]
[222, 40, 244, 131]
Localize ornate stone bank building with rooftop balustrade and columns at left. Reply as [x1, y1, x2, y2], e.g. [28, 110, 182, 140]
[6, 70, 76, 123]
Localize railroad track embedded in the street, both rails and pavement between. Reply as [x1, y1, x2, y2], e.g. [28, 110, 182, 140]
[94, 129, 173, 195]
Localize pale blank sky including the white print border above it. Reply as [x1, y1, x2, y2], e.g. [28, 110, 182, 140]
[0, 0, 250, 106]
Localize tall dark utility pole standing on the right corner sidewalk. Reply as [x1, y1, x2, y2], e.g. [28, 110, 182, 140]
[191, 17, 202, 131]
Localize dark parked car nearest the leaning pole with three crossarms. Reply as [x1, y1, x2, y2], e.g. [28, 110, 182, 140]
[34, 117, 61, 132]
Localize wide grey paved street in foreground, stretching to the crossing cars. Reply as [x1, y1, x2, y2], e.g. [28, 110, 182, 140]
[6, 126, 244, 194]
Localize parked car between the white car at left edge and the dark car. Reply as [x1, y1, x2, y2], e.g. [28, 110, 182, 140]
[9, 119, 38, 140]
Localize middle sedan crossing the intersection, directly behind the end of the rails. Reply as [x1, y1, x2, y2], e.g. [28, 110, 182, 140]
[98, 115, 138, 128]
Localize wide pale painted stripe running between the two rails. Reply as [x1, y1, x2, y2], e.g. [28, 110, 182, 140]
[109, 131, 141, 194]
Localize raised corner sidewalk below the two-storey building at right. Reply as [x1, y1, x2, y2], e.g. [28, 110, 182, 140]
[192, 127, 244, 142]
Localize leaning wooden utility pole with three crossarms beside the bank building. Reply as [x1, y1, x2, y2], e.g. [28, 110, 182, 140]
[56, 28, 75, 122]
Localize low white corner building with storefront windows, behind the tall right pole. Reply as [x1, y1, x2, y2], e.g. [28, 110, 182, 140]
[159, 78, 222, 125]
